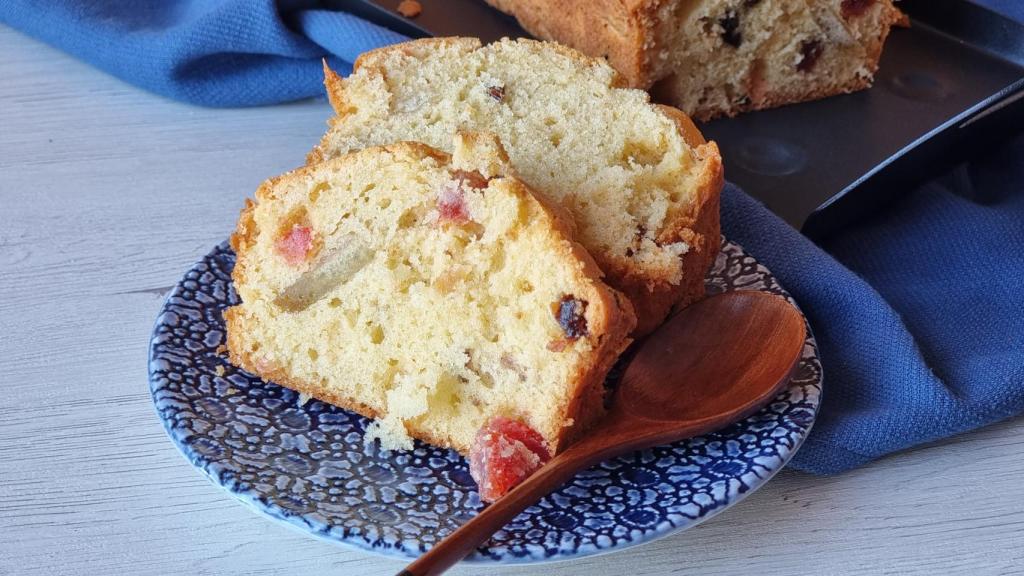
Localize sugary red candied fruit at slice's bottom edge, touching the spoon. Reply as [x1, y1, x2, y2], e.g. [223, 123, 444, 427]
[469, 416, 551, 502]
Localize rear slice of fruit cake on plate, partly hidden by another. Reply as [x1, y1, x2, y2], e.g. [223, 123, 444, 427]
[309, 38, 723, 334]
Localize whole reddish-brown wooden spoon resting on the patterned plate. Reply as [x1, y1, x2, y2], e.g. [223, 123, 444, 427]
[398, 291, 806, 576]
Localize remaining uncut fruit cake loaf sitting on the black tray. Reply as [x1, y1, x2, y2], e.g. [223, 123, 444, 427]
[487, 0, 900, 120]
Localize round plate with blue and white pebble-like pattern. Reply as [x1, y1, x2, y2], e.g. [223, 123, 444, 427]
[150, 236, 821, 563]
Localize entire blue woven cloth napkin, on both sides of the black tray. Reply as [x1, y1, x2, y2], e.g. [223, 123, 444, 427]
[0, 0, 1024, 474]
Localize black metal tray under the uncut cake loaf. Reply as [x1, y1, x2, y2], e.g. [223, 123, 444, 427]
[334, 0, 1024, 239]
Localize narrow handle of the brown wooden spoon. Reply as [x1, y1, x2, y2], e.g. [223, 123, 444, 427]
[398, 434, 615, 576]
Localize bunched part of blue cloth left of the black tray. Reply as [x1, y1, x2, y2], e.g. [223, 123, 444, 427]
[0, 0, 407, 107]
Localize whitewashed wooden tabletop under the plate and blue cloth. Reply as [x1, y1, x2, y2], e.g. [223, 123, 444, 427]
[0, 26, 1024, 576]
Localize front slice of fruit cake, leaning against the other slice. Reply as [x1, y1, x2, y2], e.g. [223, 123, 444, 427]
[224, 133, 636, 454]
